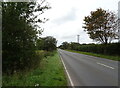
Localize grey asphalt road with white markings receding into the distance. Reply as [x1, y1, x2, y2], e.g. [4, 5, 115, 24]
[58, 49, 118, 86]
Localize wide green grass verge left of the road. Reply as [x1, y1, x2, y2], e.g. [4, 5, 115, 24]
[3, 51, 67, 86]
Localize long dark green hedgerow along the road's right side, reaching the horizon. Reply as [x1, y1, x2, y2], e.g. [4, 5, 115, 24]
[59, 42, 120, 56]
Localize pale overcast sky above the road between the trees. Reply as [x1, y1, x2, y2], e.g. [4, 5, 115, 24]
[41, 0, 120, 45]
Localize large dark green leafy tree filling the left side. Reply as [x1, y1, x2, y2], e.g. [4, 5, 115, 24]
[2, 0, 49, 74]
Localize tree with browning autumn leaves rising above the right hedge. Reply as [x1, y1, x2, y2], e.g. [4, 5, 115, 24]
[83, 8, 117, 44]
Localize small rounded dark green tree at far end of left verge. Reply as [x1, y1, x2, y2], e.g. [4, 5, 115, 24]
[36, 36, 57, 51]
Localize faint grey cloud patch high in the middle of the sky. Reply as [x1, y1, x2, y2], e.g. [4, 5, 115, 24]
[53, 8, 76, 25]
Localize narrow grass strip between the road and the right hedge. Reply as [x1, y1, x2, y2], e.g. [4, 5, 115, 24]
[67, 50, 120, 61]
